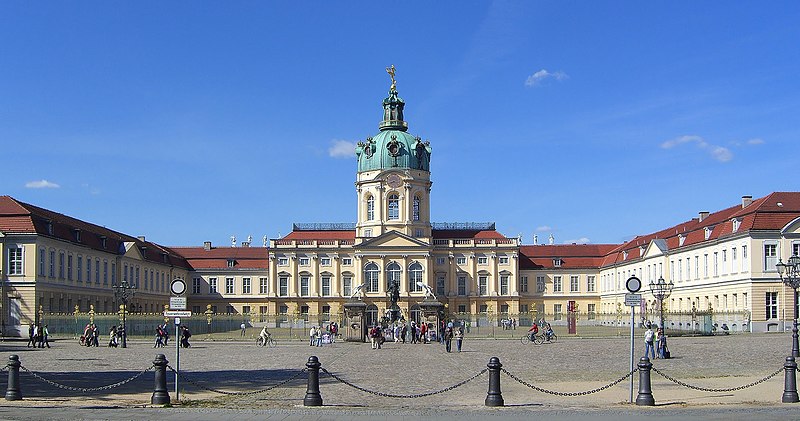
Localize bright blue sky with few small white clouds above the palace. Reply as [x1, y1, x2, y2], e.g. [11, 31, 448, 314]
[0, 1, 800, 245]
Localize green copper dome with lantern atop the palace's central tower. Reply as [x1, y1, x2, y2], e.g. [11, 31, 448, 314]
[356, 83, 431, 172]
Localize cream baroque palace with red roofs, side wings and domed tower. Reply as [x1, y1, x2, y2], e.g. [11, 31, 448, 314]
[0, 73, 800, 335]
